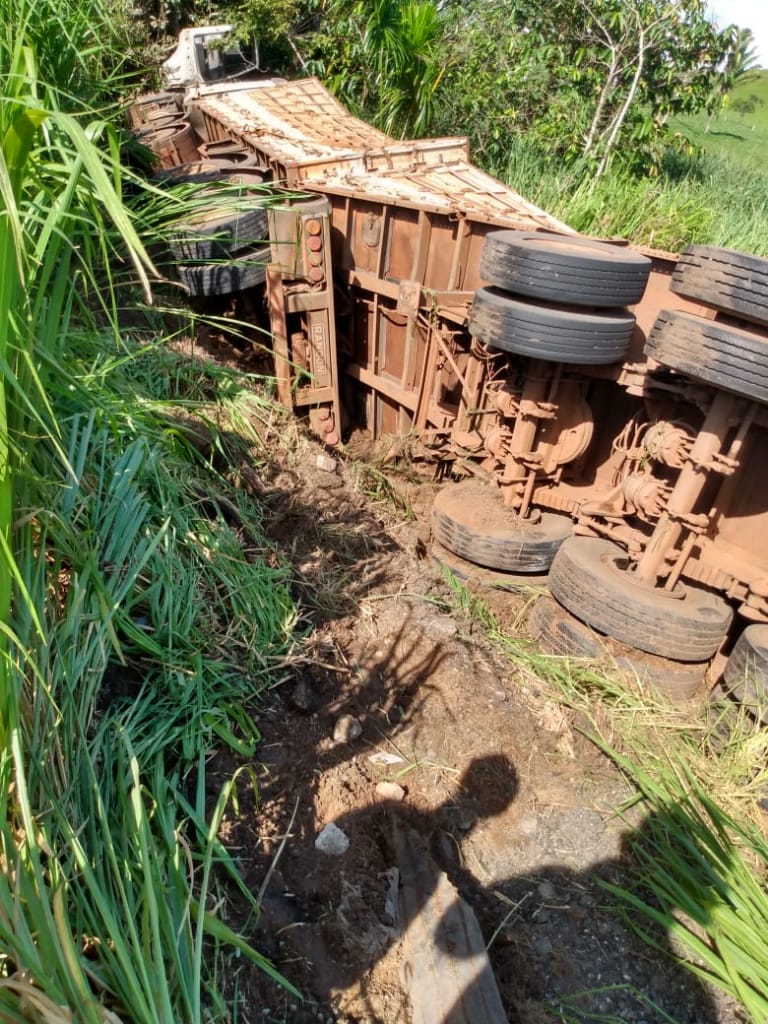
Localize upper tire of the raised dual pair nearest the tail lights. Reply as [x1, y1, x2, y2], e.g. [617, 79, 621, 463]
[480, 231, 651, 308]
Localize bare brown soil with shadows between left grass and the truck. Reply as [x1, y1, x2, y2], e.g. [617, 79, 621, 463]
[188, 337, 744, 1024]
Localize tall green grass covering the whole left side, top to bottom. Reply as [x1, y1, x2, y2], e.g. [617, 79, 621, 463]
[0, 0, 296, 1024]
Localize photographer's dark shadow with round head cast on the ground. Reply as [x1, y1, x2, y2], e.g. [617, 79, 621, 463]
[253, 754, 719, 1024]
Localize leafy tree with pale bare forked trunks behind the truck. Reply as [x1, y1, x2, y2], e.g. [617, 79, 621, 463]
[436, 0, 727, 174]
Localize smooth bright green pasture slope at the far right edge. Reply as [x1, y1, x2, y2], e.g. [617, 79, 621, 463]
[671, 71, 768, 170]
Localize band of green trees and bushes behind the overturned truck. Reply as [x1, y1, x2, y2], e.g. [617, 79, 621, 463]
[128, 0, 750, 175]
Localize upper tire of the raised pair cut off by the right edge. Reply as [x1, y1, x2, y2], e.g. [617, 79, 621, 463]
[672, 246, 768, 326]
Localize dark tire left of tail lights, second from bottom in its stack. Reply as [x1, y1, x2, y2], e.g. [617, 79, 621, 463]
[168, 207, 269, 263]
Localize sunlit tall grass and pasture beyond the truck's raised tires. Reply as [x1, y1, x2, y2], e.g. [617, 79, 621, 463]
[490, 71, 768, 256]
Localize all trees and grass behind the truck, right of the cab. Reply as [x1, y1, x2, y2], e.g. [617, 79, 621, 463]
[298, 0, 768, 255]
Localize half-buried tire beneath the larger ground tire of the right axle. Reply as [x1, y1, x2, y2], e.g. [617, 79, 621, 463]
[528, 597, 710, 701]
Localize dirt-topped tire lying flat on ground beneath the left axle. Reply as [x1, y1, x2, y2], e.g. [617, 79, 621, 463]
[432, 480, 573, 572]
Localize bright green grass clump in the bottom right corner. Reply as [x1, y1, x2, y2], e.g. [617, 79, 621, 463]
[603, 752, 768, 1024]
